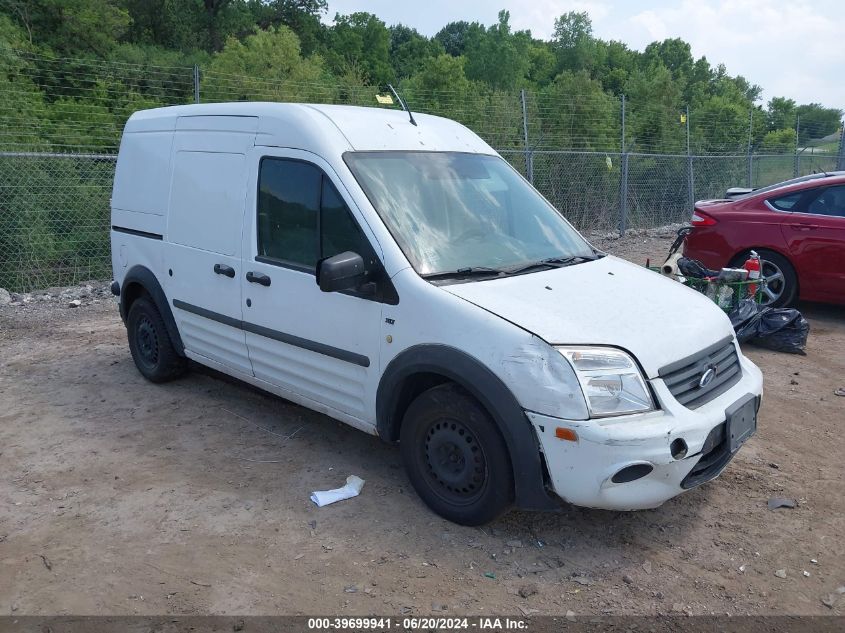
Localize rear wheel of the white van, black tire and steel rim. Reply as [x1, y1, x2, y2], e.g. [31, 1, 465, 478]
[126, 297, 188, 382]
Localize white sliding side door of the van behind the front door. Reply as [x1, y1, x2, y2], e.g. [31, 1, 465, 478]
[164, 116, 257, 375]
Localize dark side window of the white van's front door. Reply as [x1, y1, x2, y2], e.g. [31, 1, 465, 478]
[258, 158, 375, 270]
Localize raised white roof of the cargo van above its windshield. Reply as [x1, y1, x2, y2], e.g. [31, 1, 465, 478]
[124, 102, 495, 154]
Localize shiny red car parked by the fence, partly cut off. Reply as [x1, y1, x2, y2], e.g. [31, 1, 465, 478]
[684, 172, 845, 307]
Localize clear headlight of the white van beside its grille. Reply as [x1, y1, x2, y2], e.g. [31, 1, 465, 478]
[557, 347, 654, 418]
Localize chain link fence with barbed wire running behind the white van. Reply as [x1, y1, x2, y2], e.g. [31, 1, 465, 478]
[0, 51, 845, 291]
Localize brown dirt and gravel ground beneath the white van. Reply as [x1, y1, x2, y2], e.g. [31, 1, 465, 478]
[0, 233, 845, 615]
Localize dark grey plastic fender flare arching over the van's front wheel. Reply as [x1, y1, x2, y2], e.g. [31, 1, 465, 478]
[376, 345, 560, 510]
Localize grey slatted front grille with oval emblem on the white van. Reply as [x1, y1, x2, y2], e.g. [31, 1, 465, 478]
[657, 337, 742, 409]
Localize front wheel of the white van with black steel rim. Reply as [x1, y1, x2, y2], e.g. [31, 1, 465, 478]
[399, 384, 514, 525]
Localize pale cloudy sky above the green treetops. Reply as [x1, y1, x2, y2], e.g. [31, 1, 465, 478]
[326, 0, 845, 109]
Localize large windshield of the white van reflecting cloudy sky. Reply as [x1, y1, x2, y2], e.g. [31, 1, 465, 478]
[344, 151, 596, 276]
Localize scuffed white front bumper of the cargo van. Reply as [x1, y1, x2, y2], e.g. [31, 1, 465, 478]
[526, 354, 763, 510]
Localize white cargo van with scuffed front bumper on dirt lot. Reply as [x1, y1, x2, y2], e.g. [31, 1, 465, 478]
[111, 103, 762, 524]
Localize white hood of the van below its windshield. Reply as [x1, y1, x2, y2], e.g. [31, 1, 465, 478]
[442, 255, 733, 378]
